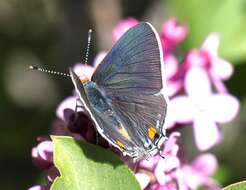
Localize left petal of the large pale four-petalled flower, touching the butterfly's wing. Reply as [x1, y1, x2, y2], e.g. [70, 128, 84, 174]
[168, 96, 196, 123]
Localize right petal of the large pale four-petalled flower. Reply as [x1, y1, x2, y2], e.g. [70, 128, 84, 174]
[208, 94, 239, 123]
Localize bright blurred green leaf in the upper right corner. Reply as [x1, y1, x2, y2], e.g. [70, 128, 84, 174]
[166, 0, 246, 63]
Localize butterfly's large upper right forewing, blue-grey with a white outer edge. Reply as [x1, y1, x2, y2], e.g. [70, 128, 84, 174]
[92, 23, 163, 94]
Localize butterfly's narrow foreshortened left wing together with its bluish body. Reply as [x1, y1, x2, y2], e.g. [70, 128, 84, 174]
[69, 69, 146, 157]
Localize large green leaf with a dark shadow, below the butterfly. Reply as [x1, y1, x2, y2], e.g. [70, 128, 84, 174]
[51, 136, 140, 190]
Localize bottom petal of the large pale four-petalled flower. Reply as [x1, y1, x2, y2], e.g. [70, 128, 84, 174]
[193, 113, 221, 151]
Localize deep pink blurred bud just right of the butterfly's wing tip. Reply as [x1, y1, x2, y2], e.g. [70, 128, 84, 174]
[161, 18, 188, 53]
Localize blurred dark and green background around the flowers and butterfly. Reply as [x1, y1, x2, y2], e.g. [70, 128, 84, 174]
[0, 0, 246, 190]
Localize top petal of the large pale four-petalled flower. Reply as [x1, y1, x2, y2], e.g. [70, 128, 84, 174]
[184, 67, 212, 98]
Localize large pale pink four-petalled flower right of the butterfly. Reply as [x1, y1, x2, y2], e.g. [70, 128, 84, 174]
[169, 67, 239, 150]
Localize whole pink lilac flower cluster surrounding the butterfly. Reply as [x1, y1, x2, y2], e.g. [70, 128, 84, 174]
[28, 18, 239, 190]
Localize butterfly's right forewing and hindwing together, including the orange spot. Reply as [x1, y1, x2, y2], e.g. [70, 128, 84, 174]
[92, 23, 167, 156]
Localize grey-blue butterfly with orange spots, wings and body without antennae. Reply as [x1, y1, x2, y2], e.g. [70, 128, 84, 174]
[69, 22, 168, 160]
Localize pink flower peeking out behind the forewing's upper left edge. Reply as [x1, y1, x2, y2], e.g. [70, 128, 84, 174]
[112, 17, 139, 42]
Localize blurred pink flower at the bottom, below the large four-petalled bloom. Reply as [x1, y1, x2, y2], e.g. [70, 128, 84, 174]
[181, 154, 220, 190]
